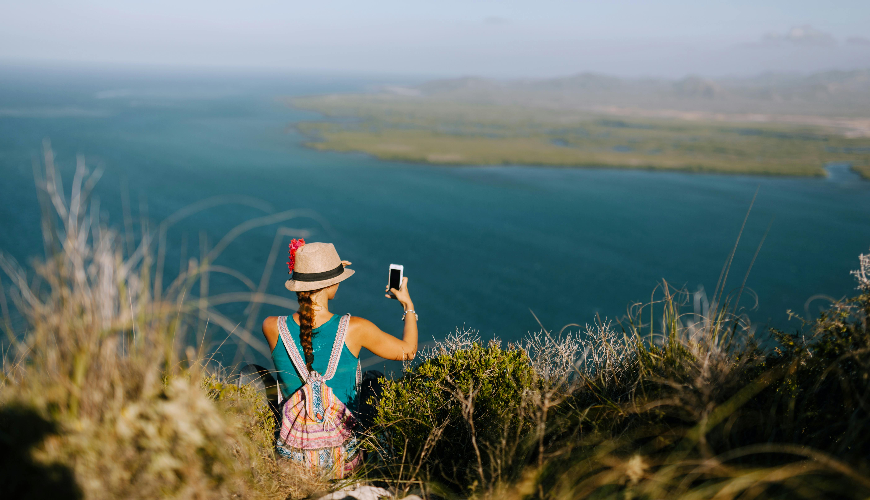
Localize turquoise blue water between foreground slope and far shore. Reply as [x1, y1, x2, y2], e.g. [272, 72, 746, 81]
[0, 65, 870, 372]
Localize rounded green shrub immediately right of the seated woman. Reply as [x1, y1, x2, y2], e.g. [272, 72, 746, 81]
[373, 336, 536, 488]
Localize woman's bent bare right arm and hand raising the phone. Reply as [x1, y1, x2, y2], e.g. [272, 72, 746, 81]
[348, 278, 417, 361]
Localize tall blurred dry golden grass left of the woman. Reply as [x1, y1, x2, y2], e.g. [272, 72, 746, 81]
[0, 143, 332, 498]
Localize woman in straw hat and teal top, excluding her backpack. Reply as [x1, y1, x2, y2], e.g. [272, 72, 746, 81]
[263, 240, 417, 432]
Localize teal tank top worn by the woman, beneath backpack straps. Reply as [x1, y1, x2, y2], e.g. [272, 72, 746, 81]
[272, 314, 358, 409]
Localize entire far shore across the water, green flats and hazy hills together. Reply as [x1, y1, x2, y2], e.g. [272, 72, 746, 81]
[290, 68, 870, 178]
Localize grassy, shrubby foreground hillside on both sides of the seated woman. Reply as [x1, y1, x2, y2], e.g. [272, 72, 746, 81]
[0, 143, 870, 500]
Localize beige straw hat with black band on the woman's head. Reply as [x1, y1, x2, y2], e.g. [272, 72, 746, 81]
[284, 243, 353, 292]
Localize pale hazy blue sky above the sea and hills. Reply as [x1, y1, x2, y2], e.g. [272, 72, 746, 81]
[0, 0, 870, 78]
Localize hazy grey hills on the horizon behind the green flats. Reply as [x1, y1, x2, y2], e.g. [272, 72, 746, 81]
[393, 69, 870, 117]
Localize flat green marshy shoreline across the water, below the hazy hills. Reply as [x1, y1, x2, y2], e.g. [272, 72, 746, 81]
[289, 95, 870, 179]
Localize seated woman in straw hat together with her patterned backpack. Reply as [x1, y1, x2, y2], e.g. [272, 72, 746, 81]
[263, 239, 417, 479]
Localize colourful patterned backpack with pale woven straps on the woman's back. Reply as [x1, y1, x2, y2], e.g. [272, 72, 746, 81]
[275, 314, 362, 479]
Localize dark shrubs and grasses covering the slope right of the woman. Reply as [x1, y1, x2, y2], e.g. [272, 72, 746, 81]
[377, 272, 870, 499]
